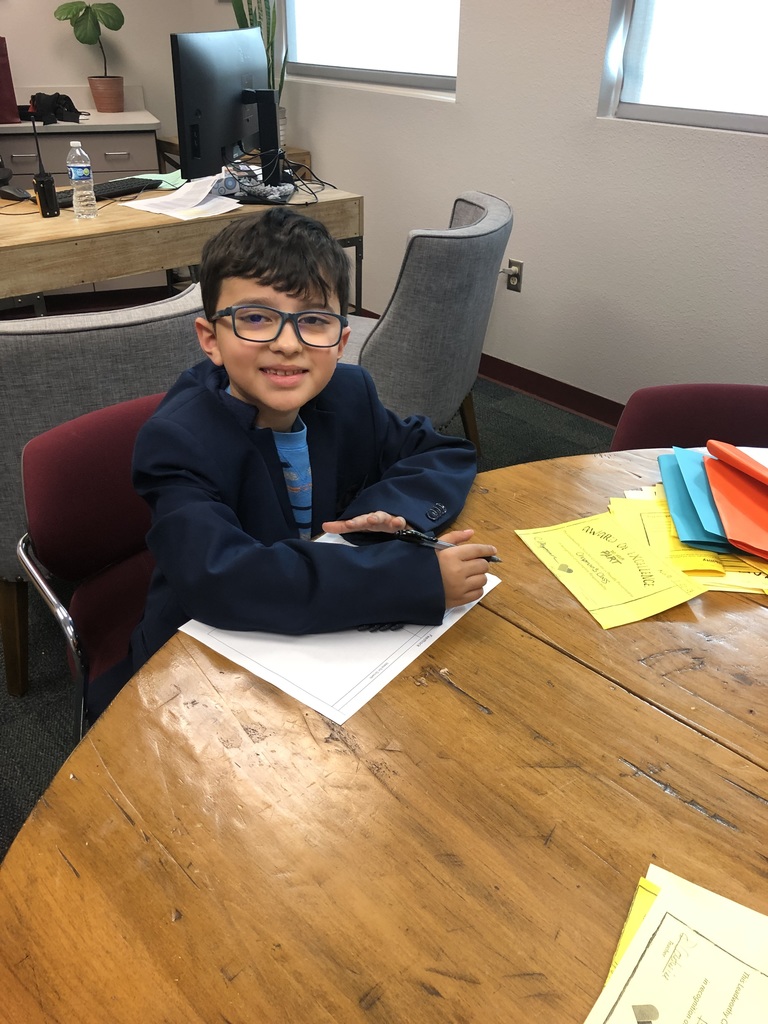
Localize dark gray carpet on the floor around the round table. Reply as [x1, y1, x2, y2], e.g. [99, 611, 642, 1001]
[0, 380, 613, 857]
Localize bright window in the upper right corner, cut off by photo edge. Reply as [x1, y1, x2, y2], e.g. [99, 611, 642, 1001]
[598, 0, 768, 132]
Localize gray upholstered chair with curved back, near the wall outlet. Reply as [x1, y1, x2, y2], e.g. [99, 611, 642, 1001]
[342, 191, 512, 447]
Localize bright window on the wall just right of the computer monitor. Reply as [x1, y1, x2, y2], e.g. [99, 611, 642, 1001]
[287, 0, 460, 91]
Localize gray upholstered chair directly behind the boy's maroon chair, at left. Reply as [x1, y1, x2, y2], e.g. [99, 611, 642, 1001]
[0, 285, 203, 694]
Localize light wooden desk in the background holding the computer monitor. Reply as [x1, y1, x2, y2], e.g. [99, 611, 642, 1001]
[0, 188, 362, 298]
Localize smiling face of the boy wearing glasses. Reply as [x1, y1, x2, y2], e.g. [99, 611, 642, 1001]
[195, 278, 349, 432]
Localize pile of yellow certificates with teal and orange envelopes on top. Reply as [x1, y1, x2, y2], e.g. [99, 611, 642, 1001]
[517, 441, 768, 629]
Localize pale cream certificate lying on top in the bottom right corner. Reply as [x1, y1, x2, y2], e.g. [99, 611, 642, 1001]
[586, 865, 768, 1024]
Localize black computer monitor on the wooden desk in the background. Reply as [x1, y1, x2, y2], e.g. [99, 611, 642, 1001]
[171, 29, 281, 184]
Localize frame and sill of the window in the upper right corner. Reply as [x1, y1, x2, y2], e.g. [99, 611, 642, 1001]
[597, 0, 768, 134]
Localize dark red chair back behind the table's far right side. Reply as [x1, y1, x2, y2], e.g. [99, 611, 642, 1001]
[610, 384, 768, 452]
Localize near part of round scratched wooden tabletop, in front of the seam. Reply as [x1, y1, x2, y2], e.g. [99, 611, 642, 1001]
[0, 602, 768, 1024]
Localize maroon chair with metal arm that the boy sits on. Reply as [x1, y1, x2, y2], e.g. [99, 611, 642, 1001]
[17, 394, 163, 740]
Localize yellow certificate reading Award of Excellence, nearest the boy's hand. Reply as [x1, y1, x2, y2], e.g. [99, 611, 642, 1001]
[516, 512, 707, 630]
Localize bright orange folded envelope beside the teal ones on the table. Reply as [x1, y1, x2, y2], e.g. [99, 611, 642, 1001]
[705, 440, 768, 558]
